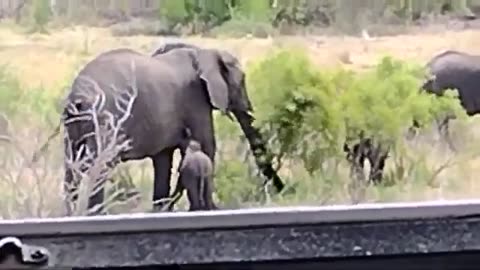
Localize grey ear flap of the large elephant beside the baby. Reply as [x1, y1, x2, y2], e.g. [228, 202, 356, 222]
[197, 49, 229, 113]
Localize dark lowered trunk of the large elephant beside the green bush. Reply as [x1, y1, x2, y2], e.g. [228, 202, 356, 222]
[233, 108, 285, 192]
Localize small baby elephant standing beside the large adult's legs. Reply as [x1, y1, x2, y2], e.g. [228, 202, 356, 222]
[170, 138, 217, 211]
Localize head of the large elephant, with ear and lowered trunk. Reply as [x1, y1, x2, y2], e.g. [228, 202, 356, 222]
[152, 42, 284, 191]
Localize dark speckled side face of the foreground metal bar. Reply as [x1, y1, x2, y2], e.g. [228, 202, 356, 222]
[8, 208, 480, 269]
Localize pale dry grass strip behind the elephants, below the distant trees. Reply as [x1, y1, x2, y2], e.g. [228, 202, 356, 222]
[0, 27, 480, 86]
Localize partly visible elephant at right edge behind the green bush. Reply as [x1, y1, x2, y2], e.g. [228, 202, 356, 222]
[422, 50, 480, 149]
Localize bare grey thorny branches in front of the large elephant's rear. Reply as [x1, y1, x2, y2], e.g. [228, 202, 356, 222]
[65, 62, 138, 215]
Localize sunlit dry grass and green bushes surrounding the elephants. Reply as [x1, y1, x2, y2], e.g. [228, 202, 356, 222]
[0, 0, 480, 218]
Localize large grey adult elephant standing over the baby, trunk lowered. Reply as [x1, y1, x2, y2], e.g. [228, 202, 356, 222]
[63, 44, 283, 215]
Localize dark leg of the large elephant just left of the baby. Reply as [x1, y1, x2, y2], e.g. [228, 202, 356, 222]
[152, 147, 175, 211]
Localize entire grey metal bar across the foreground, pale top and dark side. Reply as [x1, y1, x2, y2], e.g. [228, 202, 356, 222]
[0, 201, 480, 270]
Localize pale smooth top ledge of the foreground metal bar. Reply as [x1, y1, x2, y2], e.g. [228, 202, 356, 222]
[0, 200, 480, 236]
